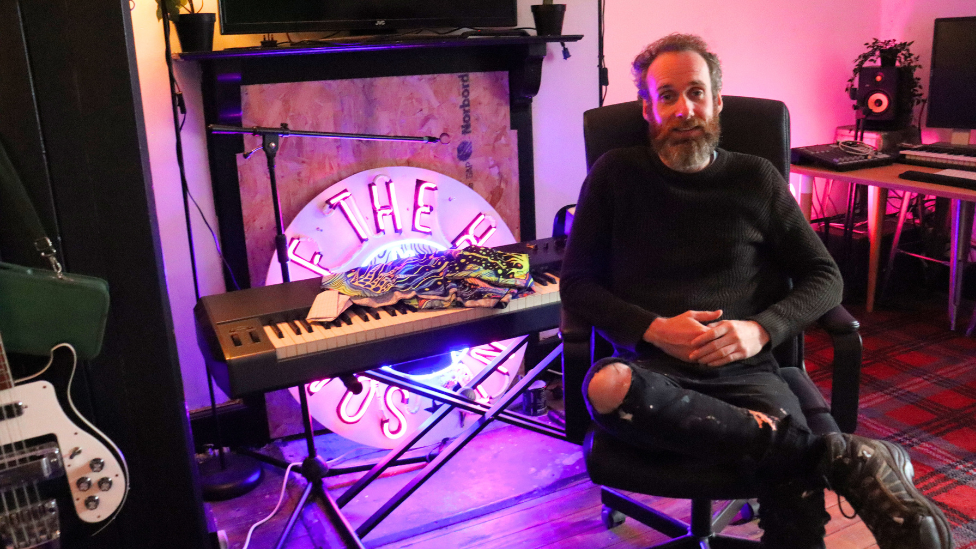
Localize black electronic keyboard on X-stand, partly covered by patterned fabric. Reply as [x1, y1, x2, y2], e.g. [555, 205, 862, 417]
[194, 237, 565, 398]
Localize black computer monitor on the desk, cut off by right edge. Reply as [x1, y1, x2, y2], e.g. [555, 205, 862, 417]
[926, 17, 976, 143]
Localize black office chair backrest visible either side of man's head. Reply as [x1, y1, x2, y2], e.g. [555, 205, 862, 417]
[583, 95, 790, 178]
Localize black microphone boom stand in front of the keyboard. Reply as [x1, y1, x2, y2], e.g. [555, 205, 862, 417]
[207, 123, 448, 549]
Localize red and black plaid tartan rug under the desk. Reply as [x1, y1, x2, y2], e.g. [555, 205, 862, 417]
[806, 294, 976, 549]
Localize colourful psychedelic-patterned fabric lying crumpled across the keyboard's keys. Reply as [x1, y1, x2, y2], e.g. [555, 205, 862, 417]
[322, 246, 532, 309]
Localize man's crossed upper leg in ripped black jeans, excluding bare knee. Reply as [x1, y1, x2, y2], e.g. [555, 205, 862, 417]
[583, 357, 819, 474]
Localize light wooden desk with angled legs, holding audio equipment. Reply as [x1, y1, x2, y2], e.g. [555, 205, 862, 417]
[790, 164, 976, 329]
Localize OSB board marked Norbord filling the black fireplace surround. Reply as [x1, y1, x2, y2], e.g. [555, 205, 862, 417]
[237, 72, 520, 286]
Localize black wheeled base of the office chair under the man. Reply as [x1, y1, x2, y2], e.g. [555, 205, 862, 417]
[600, 487, 760, 549]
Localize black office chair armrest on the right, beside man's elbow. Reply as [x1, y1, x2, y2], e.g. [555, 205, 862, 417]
[817, 305, 862, 433]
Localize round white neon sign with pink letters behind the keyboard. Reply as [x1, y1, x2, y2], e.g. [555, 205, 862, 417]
[265, 166, 524, 448]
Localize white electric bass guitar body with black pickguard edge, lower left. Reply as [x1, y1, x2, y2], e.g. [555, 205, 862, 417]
[0, 332, 128, 549]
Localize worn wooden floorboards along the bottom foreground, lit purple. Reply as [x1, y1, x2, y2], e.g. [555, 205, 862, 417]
[210, 462, 877, 549]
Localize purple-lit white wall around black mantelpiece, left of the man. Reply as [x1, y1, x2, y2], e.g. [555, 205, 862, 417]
[132, 0, 597, 409]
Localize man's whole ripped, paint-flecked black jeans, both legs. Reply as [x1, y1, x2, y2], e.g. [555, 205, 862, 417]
[583, 357, 829, 549]
